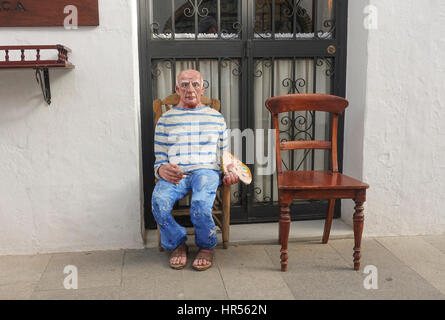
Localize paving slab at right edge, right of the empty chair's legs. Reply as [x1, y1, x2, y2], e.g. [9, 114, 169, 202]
[377, 237, 445, 294]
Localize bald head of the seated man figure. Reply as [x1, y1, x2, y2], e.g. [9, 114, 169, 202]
[176, 70, 204, 109]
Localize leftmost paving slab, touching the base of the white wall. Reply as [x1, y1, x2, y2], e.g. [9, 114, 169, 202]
[0, 254, 51, 285]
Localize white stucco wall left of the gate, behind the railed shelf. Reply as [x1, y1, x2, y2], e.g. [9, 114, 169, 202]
[0, 0, 142, 254]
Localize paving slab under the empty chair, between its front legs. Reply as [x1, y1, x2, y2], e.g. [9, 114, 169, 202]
[266, 241, 366, 300]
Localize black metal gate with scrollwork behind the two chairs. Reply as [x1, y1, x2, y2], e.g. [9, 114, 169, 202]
[139, 0, 347, 227]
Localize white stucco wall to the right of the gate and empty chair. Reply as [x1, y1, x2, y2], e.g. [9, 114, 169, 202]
[343, 0, 445, 236]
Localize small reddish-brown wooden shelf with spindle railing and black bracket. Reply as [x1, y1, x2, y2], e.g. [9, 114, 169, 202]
[0, 44, 74, 105]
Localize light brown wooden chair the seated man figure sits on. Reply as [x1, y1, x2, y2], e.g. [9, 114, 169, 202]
[153, 93, 230, 251]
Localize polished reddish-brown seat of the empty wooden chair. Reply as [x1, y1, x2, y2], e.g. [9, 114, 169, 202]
[278, 171, 369, 190]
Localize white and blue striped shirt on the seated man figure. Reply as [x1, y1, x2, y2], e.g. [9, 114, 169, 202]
[154, 106, 228, 179]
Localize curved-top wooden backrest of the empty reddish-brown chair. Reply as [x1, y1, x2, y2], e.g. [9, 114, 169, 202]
[266, 93, 349, 174]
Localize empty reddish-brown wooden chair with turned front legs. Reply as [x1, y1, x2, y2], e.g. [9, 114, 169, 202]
[266, 94, 369, 271]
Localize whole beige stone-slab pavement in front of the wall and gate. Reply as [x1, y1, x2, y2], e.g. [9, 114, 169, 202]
[0, 224, 445, 300]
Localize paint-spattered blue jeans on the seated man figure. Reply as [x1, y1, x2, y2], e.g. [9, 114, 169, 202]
[151, 169, 221, 250]
